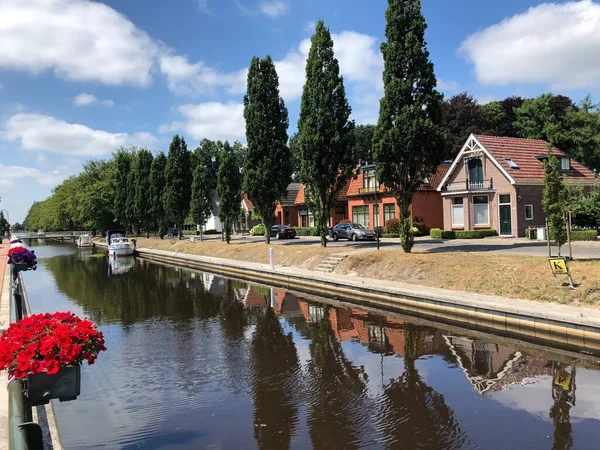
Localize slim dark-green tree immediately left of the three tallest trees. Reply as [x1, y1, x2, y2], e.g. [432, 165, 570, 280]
[217, 141, 242, 244]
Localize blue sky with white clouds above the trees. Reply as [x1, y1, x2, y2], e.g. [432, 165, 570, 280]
[0, 0, 600, 222]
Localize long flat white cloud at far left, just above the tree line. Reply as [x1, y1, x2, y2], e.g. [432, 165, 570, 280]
[0, 113, 156, 156]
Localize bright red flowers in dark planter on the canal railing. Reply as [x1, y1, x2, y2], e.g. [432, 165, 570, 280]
[0, 312, 106, 406]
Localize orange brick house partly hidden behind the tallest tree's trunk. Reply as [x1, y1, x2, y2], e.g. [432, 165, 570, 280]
[344, 164, 450, 232]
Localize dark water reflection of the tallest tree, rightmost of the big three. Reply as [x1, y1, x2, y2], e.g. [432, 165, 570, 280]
[380, 324, 466, 450]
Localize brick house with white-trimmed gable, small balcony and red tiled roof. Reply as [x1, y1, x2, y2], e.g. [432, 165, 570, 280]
[437, 134, 598, 237]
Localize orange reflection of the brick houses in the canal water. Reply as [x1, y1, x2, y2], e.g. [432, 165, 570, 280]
[299, 300, 445, 356]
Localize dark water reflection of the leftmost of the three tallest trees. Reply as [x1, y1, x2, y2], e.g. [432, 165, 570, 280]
[251, 306, 300, 449]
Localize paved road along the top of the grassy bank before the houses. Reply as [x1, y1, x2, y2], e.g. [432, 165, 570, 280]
[164, 235, 600, 259]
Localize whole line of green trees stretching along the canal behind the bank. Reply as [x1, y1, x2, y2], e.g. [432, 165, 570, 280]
[25, 0, 600, 252]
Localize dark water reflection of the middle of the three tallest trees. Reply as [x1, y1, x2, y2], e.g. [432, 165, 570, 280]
[306, 308, 370, 448]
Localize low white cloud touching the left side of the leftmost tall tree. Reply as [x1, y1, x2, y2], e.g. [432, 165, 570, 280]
[160, 102, 246, 141]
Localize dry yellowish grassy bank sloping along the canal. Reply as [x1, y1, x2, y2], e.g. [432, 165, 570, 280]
[127, 239, 600, 309]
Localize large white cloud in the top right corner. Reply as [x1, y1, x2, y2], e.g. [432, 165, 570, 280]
[459, 0, 600, 89]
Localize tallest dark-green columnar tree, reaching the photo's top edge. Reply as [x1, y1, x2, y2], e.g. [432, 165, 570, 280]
[373, 0, 446, 252]
